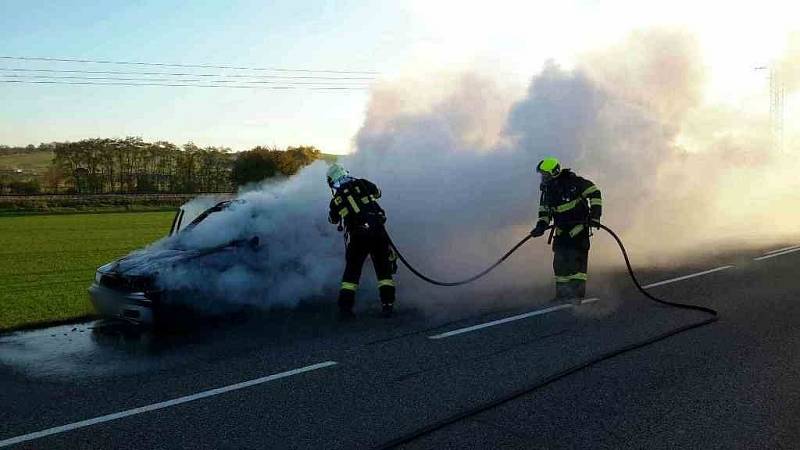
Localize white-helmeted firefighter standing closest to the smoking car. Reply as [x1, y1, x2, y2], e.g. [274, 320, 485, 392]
[327, 164, 397, 318]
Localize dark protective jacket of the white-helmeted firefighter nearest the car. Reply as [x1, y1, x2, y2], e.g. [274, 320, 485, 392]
[328, 178, 386, 233]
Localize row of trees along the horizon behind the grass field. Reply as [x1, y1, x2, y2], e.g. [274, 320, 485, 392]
[0, 137, 326, 194]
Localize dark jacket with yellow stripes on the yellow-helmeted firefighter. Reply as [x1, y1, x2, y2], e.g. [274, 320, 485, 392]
[538, 169, 603, 245]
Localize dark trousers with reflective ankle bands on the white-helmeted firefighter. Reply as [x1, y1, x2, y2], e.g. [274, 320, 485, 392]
[339, 226, 395, 310]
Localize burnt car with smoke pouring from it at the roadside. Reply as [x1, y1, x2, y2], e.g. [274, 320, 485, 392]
[89, 200, 262, 325]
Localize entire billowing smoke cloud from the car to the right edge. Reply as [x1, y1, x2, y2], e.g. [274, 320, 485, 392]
[134, 30, 800, 312]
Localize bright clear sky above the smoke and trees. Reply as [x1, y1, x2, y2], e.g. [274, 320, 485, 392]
[0, 0, 800, 153]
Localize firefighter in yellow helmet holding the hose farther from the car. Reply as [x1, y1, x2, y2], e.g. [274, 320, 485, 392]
[531, 157, 603, 303]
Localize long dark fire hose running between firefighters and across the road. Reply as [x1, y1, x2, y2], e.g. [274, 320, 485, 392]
[377, 223, 719, 449]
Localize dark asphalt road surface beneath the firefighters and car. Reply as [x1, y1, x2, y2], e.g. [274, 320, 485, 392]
[0, 242, 800, 449]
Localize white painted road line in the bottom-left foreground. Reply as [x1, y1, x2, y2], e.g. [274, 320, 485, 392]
[0, 361, 337, 447]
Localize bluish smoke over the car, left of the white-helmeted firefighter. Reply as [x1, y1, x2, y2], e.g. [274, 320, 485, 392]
[118, 161, 343, 309]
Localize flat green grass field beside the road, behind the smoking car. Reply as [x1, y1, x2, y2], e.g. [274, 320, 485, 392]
[0, 212, 174, 330]
